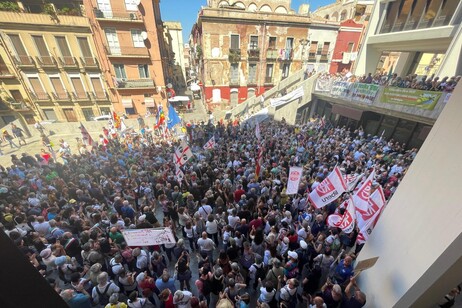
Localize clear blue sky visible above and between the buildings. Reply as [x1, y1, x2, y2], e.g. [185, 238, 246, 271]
[160, 0, 335, 43]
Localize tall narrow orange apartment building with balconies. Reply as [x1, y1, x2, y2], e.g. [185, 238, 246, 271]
[83, 0, 168, 116]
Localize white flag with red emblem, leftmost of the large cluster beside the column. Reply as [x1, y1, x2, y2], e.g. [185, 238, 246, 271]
[309, 167, 347, 208]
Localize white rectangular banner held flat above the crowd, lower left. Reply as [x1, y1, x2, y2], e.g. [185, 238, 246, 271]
[122, 228, 176, 246]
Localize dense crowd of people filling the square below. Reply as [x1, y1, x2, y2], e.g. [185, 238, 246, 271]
[0, 116, 417, 308]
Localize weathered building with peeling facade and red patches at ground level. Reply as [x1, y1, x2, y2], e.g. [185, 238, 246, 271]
[190, 0, 338, 108]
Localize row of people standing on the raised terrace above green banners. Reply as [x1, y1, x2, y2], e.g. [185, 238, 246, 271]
[320, 71, 461, 92]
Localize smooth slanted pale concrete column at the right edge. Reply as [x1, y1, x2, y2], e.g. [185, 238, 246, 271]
[358, 84, 462, 307]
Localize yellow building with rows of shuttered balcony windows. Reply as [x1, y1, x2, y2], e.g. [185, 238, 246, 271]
[0, 0, 111, 122]
